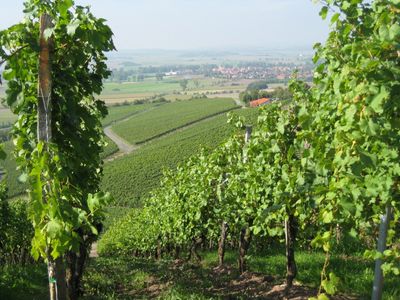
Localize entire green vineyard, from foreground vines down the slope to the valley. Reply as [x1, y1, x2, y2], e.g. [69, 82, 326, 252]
[0, 0, 400, 300]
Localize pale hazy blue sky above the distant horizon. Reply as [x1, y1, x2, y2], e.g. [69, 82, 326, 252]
[0, 0, 328, 50]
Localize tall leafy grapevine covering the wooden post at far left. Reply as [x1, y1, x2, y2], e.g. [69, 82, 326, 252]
[0, 0, 114, 299]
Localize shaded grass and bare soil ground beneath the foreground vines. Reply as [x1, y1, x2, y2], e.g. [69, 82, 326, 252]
[78, 246, 400, 300]
